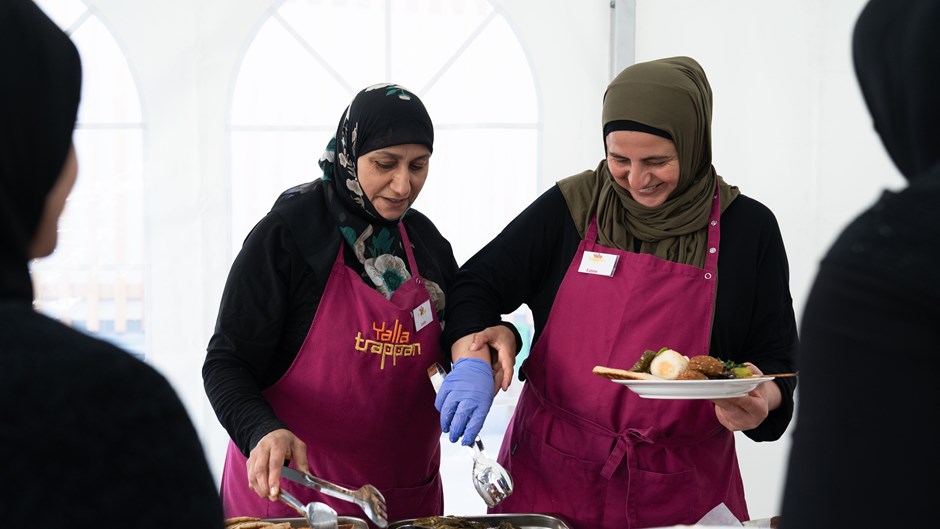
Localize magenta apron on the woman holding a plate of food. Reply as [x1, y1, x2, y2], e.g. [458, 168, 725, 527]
[489, 186, 748, 529]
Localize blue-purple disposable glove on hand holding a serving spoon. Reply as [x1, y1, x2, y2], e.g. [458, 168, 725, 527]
[434, 358, 496, 446]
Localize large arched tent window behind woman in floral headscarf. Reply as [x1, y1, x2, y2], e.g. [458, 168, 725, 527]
[230, 0, 541, 262]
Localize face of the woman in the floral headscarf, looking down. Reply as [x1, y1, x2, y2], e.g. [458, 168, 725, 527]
[356, 143, 431, 220]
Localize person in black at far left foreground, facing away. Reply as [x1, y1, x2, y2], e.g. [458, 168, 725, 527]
[0, 0, 223, 528]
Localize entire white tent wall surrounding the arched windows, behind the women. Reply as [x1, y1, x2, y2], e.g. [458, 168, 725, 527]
[42, 0, 902, 518]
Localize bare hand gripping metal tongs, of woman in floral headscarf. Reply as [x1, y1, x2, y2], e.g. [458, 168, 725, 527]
[247, 429, 310, 501]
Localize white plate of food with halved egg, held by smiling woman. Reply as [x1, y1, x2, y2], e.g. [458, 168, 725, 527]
[594, 347, 775, 399]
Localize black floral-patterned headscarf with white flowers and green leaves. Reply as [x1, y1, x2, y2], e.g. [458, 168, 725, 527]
[320, 83, 442, 302]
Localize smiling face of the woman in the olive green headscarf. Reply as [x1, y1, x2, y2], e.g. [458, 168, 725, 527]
[606, 130, 680, 208]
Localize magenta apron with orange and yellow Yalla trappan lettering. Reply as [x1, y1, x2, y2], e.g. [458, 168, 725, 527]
[221, 223, 444, 521]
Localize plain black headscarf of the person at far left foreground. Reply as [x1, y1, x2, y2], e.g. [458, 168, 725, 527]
[0, 0, 82, 303]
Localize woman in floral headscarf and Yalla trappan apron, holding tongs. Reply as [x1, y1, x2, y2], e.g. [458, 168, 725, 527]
[203, 84, 492, 520]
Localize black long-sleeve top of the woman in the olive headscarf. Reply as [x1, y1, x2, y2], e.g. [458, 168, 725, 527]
[442, 186, 798, 441]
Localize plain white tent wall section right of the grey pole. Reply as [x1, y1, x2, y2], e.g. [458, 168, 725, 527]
[635, 0, 904, 518]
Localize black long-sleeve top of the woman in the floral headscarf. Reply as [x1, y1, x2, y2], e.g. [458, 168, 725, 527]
[202, 180, 457, 457]
